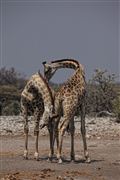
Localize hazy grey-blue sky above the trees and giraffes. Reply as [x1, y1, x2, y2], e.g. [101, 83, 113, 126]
[0, 0, 120, 82]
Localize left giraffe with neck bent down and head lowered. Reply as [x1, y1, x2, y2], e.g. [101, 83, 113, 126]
[21, 72, 55, 160]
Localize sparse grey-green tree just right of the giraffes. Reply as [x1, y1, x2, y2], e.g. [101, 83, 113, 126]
[86, 69, 117, 114]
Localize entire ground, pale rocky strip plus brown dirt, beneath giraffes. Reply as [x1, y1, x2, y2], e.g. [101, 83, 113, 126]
[0, 116, 120, 180]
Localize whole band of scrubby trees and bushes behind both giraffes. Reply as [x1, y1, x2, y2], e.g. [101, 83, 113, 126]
[0, 67, 120, 116]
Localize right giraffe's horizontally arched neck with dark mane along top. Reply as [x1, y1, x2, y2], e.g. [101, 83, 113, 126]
[51, 59, 80, 70]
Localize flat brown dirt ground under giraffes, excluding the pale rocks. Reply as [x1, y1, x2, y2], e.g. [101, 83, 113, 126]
[0, 135, 120, 180]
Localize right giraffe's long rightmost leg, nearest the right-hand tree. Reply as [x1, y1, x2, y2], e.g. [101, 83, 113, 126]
[81, 104, 90, 163]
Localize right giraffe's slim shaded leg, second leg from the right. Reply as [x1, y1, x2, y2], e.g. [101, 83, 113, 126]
[70, 119, 75, 161]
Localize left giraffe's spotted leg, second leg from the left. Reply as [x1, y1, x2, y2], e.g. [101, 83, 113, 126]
[34, 109, 40, 161]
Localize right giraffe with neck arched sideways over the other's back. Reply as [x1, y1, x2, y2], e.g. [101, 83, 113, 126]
[43, 59, 90, 163]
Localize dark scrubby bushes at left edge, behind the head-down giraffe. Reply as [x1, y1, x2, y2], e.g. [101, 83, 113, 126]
[0, 67, 26, 115]
